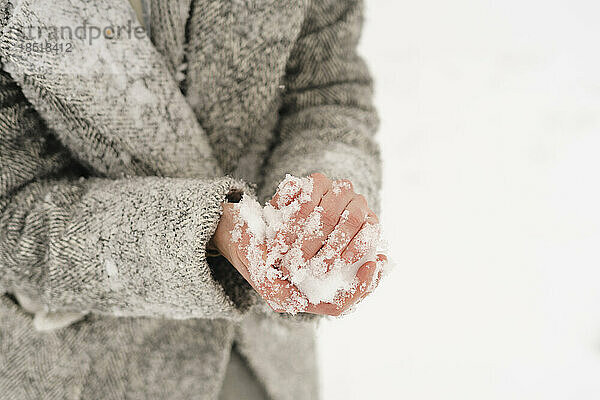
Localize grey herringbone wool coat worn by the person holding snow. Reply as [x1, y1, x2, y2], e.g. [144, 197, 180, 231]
[0, 0, 380, 400]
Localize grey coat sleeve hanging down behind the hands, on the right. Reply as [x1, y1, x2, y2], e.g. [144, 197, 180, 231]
[259, 0, 381, 210]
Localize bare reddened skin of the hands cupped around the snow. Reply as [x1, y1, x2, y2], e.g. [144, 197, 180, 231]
[213, 173, 387, 315]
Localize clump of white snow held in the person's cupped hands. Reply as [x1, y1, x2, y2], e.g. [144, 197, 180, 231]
[231, 175, 386, 314]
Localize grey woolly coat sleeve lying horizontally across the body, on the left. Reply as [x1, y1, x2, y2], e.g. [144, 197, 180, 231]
[0, 72, 251, 319]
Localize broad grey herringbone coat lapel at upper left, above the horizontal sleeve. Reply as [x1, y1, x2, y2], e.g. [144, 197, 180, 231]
[0, 0, 221, 177]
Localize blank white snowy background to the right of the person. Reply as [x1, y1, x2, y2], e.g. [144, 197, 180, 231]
[319, 0, 600, 400]
